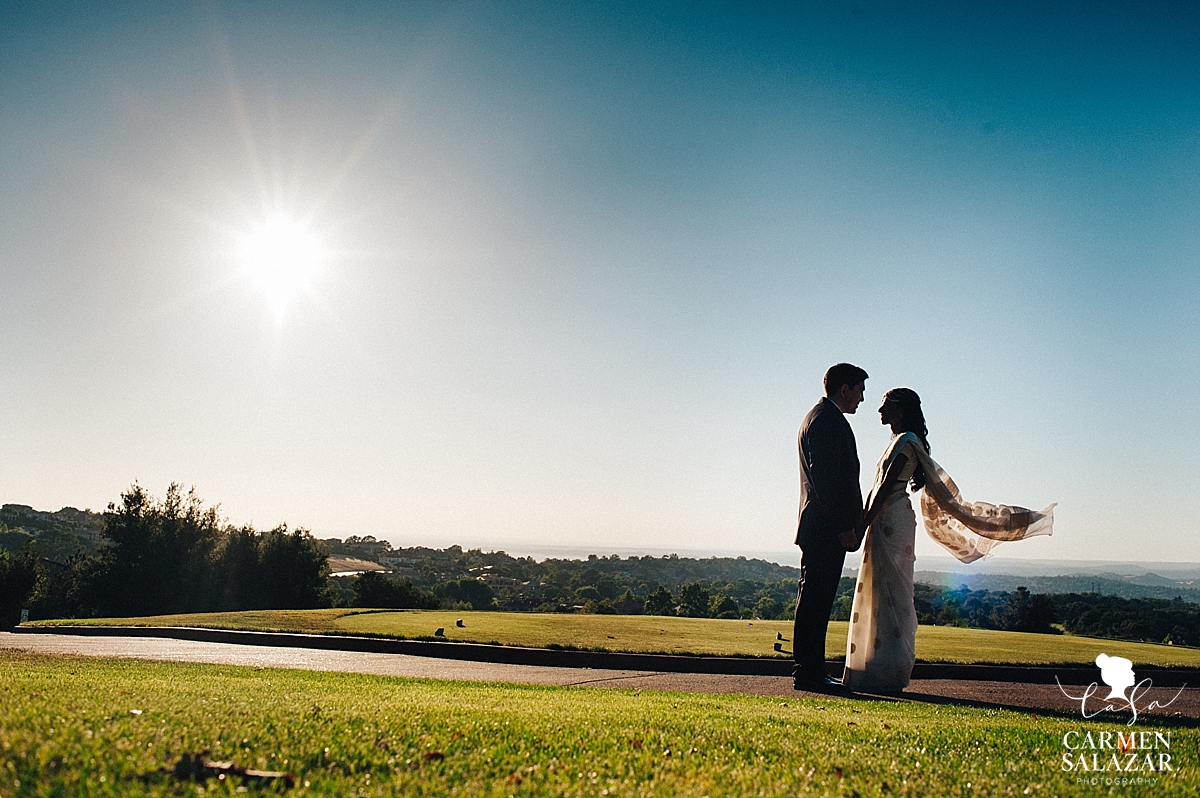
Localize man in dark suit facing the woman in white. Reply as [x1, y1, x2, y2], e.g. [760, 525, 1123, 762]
[792, 362, 866, 692]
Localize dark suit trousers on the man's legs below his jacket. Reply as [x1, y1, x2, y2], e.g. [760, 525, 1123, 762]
[792, 544, 846, 680]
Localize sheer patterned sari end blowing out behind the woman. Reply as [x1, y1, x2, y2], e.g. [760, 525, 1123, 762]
[913, 446, 1055, 563]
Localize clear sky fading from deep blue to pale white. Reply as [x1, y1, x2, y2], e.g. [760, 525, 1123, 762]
[0, 2, 1200, 566]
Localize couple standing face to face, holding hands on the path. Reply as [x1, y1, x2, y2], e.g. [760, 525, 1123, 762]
[792, 364, 1054, 692]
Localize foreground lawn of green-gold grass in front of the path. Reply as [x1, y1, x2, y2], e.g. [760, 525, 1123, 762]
[0, 650, 1200, 798]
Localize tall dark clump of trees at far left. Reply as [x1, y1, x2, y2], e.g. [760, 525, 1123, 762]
[0, 484, 334, 624]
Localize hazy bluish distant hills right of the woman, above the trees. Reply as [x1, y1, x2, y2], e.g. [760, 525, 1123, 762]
[913, 571, 1200, 604]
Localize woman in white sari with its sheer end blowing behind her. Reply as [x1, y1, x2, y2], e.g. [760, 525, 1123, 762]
[842, 388, 1054, 692]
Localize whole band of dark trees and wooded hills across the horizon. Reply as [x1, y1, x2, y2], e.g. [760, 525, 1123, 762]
[0, 485, 1200, 646]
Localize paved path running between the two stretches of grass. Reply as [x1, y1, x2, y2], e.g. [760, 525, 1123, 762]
[0, 632, 1200, 722]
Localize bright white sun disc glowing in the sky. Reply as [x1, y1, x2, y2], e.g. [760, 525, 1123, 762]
[238, 215, 325, 317]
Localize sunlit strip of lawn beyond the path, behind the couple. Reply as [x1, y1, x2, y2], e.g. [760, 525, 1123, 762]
[32, 610, 1200, 667]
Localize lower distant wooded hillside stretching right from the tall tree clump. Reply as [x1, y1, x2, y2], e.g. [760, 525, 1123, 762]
[323, 538, 1200, 646]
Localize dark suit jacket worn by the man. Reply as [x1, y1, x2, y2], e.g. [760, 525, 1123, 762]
[796, 398, 863, 550]
